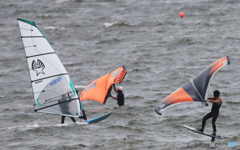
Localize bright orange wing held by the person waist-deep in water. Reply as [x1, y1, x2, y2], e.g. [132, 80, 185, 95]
[80, 66, 127, 104]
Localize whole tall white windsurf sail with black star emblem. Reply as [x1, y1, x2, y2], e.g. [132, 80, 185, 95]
[17, 19, 85, 117]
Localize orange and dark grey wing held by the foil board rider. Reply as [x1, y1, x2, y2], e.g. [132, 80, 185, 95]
[155, 56, 231, 115]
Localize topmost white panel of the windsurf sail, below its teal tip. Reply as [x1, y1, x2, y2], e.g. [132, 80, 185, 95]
[18, 20, 43, 37]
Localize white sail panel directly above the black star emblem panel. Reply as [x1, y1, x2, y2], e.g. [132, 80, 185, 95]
[23, 37, 55, 57]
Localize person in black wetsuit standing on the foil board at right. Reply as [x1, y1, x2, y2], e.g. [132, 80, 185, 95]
[198, 90, 222, 136]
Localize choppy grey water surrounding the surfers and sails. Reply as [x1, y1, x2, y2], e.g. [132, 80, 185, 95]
[0, 0, 240, 150]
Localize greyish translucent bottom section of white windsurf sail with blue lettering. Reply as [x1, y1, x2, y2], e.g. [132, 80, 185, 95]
[35, 75, 80, 115]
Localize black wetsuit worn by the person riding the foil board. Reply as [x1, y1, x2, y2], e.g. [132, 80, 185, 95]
[202, 101, 222, 132]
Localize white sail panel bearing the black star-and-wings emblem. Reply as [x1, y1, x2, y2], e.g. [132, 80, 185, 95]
[27, 54, 67, 81]
